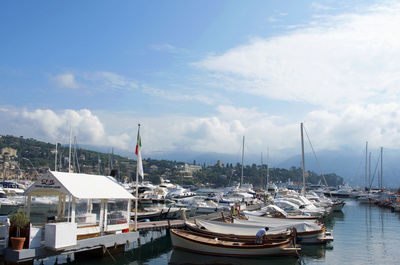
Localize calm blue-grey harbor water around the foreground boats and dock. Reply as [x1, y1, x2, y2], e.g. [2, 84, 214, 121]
[44, 200, 400, 265]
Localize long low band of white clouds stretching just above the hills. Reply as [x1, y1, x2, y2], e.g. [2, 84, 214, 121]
[0, 103, 400, 162]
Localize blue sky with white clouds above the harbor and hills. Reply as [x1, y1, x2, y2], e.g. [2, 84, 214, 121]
[0, 0, 400, 164]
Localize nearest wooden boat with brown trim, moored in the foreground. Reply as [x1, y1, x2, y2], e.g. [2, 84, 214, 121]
[170, 229, 301, 257]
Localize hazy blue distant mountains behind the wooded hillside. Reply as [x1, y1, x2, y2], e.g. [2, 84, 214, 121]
[68, 145, 400, 188]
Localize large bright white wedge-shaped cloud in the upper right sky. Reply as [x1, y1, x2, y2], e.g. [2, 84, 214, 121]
[194, 4, 400, 109]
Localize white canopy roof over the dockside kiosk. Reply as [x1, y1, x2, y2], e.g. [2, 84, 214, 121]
[26, 171, 135, 199]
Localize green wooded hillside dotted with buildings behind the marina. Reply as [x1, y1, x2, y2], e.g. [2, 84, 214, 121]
[0, 135, 343, 187]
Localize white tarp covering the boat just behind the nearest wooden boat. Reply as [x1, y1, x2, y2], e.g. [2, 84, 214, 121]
[196, 216, 322, 236]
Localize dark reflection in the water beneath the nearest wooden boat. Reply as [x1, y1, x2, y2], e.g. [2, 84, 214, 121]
[169, 249, 301, 265]
